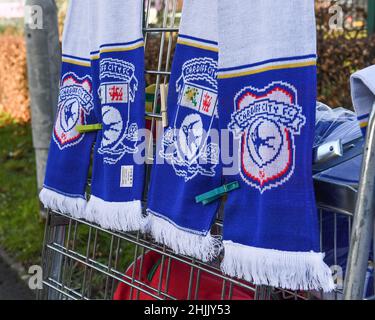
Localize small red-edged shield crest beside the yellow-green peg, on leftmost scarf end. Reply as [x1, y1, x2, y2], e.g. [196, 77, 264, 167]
[53, 72, 94, 150]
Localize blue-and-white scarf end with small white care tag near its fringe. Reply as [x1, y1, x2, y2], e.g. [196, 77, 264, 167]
[86, 0, 145, 231]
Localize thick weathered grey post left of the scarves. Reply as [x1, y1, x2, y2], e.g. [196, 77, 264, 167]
[25, 0, 61, 218]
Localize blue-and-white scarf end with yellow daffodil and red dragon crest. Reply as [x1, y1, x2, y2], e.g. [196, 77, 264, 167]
[147, 0, 221, 261]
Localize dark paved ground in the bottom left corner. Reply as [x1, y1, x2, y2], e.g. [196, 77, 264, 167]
[0, 258, 35, 300]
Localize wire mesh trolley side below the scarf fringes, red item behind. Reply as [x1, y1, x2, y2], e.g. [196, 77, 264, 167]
[39, 210, 351, 300]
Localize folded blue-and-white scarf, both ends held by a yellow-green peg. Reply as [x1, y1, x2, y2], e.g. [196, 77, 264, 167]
[41, 0, 145, 231]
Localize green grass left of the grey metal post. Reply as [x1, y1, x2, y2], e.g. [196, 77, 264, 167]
[0, 115, 44, 267]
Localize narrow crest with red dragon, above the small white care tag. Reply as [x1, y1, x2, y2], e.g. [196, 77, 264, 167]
[98, 58, 138, 165]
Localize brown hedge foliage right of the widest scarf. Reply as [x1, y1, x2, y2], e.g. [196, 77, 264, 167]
[316, 1, 375, 108]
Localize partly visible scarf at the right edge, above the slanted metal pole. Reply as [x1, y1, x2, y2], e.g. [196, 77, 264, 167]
[350, 66, 375, 134]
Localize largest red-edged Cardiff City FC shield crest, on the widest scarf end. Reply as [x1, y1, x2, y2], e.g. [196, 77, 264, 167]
[229, 82, 306, 193]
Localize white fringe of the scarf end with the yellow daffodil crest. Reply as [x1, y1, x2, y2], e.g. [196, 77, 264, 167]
[145, 210, 222, 262]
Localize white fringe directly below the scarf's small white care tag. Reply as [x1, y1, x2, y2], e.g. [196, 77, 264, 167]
[85, 196, 145, 231]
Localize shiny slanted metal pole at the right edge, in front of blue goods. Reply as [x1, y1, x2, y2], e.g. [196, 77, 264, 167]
[344, 105, 375, 300]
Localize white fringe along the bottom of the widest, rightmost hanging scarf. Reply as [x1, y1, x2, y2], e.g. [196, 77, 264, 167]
[221, 241, 335, 292]
